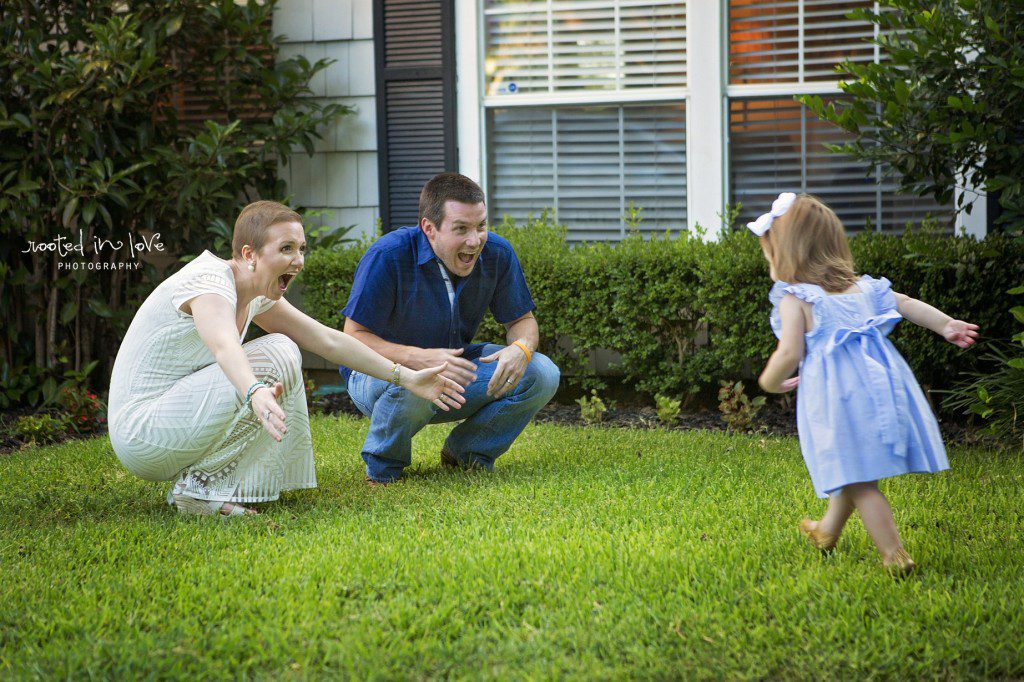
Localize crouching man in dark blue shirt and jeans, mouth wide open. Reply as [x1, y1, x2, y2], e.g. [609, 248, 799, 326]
[341, 173, 559, 484]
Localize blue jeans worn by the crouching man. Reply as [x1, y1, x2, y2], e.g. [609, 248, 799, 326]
[348, 344, 560, 482]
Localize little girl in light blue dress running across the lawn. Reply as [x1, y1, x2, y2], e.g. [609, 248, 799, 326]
[746, 193, 978, 576]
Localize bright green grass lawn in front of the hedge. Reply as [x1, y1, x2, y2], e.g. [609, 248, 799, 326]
[0, 417, 1024, 679]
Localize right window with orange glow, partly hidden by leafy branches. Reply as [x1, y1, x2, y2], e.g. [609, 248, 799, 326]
[726, 0, 952, 230]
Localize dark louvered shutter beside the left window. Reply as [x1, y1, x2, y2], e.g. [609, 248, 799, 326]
[374, 0, 459, 232]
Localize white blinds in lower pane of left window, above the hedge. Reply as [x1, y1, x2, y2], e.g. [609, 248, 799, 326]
[487, 100, 686, 241]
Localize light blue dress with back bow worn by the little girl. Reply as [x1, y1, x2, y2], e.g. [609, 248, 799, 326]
[768, 274, 949, 498]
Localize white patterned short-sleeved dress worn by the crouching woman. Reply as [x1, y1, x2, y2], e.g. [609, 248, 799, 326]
[108, 251, 316, 503]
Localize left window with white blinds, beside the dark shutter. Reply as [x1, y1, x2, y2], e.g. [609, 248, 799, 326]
[482, 0, 686, 241]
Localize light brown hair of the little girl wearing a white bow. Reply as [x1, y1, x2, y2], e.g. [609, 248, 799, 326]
[761, 195, 857, 293]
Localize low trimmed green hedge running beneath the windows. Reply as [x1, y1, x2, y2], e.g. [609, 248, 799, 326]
[302, 215, 1024, 405]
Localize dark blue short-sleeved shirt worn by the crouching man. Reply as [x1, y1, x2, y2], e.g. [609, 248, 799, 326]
[340, 227, 537, 381]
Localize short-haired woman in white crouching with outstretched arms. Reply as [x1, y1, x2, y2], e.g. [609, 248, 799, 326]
[109, 201, 465, 516]
